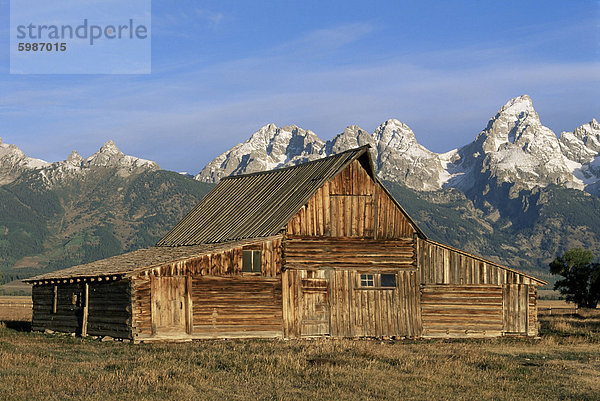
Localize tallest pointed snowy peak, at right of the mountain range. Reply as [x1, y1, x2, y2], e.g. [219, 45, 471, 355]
[445, 95, 583, 193]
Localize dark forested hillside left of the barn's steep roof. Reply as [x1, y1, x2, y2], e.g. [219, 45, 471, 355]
[0, 147, 213, 282]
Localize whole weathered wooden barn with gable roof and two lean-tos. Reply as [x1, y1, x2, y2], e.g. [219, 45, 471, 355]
[26, 147, 546, 342]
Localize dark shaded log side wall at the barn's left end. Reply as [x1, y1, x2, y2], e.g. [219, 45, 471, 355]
[32, 280, 131, 339]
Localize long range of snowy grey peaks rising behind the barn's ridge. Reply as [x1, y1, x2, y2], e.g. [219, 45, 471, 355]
[196, 95, 600, 198]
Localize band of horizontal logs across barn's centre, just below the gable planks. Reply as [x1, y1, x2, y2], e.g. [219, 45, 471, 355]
[283, 238, 416, 269]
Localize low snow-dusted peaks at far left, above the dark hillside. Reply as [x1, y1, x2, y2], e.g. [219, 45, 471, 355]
[0, 140, 160, 185]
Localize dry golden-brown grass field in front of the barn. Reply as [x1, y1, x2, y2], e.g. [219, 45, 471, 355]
[0, 310, 600, 400]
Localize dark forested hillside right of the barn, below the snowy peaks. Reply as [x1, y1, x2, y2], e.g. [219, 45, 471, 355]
[384, 181, 600, 280]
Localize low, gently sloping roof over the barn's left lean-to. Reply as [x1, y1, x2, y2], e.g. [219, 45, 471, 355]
[23, 239, 274, 282]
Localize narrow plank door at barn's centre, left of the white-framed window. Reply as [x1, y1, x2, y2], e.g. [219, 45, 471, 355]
[300, 272, 330, 336]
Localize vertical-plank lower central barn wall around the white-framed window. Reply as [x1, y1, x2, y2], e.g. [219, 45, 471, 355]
[282, 269, 421, 337]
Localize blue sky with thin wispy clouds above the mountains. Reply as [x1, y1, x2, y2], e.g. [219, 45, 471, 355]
[0, 0, 600, 173]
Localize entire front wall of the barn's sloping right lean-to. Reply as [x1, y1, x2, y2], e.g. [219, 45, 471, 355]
[417, 239, 539, 337]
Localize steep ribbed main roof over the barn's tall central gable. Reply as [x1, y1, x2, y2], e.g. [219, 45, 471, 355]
[157, 145, 425, 247]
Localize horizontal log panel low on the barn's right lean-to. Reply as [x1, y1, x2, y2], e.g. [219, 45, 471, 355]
[421, 285, 503, 337]
